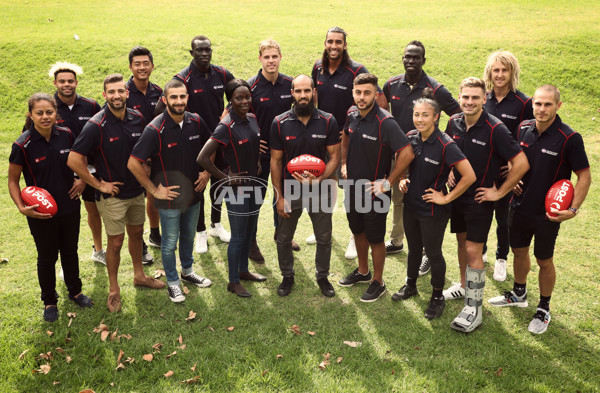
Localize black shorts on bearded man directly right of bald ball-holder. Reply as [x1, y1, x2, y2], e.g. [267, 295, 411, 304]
[345, 187, 392, 244]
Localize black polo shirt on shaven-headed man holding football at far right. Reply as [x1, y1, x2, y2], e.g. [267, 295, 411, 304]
[511, 115, 590, 220]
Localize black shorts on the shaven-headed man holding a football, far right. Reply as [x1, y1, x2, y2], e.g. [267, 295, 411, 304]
[508, 209, 560, 260]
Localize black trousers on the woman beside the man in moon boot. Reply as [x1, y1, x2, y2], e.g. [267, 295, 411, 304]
[403, 205, 450, 288]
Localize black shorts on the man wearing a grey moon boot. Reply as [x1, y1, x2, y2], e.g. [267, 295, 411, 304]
[450, 202, 494, 243]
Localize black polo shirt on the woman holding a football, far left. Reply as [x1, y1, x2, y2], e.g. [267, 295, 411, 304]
[8, 125, 80, 217]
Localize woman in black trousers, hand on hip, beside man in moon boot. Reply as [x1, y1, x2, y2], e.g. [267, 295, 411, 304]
[392, 89, 476, 319]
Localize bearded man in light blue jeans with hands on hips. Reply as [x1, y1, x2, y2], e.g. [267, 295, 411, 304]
[127, 79, 211, 303]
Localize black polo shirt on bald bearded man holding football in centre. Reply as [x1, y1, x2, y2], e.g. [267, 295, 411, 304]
[271, 108, 340, 179]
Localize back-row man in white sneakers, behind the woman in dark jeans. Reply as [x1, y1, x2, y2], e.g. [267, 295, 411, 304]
[166, 35, 234, 253]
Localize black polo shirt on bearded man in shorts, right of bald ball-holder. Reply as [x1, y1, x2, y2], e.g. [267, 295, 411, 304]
[344, 103, 410, 181]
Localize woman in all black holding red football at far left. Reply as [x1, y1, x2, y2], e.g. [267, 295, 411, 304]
[8, 93, 93, 322]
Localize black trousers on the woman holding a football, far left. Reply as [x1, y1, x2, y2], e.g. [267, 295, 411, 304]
[27, 209, 81, 306]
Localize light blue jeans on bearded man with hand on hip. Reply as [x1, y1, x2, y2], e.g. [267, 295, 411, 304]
[158, 203, 200, 285]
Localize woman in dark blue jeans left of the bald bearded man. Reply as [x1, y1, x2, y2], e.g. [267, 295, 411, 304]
[198, 79, 266, 297]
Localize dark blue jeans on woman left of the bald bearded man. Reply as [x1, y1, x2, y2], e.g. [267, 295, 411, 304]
[226, 189, 260, 283]
